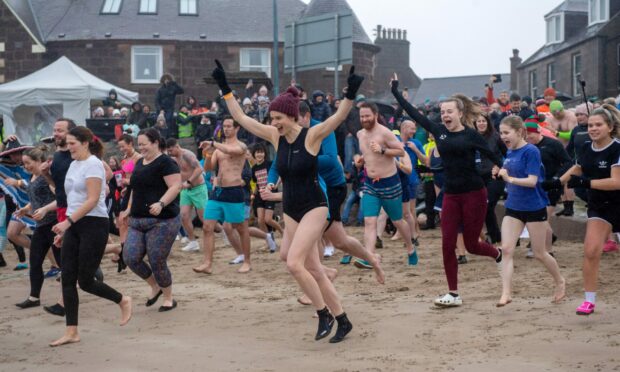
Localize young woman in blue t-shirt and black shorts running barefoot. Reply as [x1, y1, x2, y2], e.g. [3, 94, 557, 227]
[497, 116, 566, 307]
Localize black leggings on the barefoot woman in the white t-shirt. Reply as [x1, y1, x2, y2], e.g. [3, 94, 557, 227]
[61, 216, 123, 326]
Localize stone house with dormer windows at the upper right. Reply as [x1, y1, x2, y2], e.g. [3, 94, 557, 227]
[511, 0, 620, 103]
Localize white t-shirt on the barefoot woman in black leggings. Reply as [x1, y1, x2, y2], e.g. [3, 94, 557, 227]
[65, 155, 108, 217]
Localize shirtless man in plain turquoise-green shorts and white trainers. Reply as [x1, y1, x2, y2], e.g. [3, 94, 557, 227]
[166, 138, 207, 252]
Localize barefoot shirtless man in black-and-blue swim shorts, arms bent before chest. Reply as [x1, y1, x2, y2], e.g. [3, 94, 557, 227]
[193, 116, 251, 274]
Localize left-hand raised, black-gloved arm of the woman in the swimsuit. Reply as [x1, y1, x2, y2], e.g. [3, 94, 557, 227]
[211, 59, 279, 148]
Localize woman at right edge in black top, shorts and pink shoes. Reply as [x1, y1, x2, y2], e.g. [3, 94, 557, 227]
[545, 104, 620, 315]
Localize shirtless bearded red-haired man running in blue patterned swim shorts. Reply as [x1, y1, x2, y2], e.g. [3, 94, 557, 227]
[355, 103, 414, 268]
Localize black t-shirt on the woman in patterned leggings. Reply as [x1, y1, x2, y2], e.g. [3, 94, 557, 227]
[130, 154, 180, 219]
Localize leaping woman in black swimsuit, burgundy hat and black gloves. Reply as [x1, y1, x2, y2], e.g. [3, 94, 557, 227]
[212, 60, 363, 343]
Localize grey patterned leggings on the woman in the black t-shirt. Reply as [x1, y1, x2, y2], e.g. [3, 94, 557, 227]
[123, 216, 181, 288]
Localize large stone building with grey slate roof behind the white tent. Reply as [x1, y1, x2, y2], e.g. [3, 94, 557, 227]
[0, 0, 404, 112]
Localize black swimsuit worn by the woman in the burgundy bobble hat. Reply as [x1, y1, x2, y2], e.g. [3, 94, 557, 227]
[276, 128, 327, 223]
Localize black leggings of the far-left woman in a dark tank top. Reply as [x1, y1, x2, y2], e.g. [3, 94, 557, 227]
[30, 223, 60, 298]
